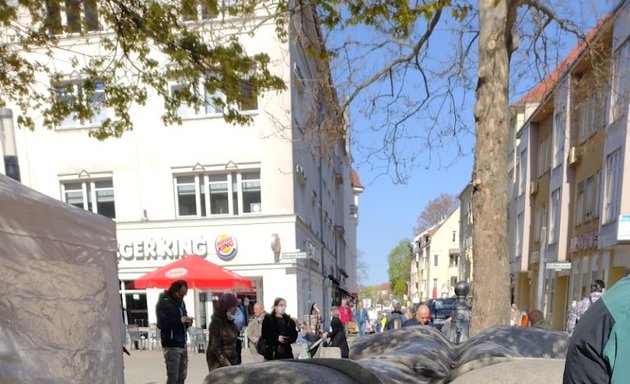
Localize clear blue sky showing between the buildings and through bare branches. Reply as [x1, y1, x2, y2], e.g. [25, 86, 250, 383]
[344, 0, 617, 285]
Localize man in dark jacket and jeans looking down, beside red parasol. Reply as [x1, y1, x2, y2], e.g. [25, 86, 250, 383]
[155, 280, 193, 384]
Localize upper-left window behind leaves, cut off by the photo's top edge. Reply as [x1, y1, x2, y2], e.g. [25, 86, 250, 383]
[46, 0, 100, 35]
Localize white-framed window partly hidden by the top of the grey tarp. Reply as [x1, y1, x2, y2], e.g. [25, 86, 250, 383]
[61, 179, 116, 219]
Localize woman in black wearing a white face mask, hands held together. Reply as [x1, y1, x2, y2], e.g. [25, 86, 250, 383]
[262, 297, 297, 360]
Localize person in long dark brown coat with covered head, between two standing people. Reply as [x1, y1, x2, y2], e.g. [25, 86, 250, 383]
[206, 293, 241, 372]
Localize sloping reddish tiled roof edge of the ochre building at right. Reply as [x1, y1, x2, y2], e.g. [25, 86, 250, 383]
[513, 15, 611, 106]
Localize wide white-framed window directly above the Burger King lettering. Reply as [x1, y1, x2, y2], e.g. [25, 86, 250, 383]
[175, 171, 262, 217]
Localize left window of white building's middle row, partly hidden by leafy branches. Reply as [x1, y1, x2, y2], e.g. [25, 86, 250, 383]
[55, 81, 107, 128]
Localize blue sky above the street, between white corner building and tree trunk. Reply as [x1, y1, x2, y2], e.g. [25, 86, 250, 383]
[344, 0, 617, 285]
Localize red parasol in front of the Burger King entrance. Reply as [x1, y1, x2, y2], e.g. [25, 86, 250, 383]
[134, 255, 254, 289]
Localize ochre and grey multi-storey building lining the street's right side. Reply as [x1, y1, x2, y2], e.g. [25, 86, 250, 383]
[508, 1, 630, 329]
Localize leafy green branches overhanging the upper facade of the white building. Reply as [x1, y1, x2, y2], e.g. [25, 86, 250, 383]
[0, 0, 287, 139]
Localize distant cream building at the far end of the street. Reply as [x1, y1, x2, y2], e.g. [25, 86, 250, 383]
[409, 207, 460, 303]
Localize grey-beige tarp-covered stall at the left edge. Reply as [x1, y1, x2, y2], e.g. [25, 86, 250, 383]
[0, 175, 124, 384]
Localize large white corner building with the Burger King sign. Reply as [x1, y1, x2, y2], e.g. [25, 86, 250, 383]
[0, 1, 363, 326]
